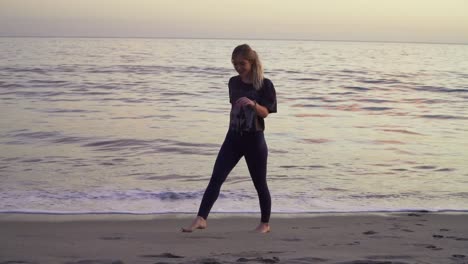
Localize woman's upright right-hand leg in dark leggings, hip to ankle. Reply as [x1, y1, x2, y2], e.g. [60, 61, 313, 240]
[245, 132, 271, 223]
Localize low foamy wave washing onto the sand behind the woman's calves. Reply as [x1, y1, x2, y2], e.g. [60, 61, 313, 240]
[0, 188, 468, 214]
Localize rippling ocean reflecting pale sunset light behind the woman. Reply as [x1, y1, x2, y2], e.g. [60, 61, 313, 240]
[0, 38, 468, 214]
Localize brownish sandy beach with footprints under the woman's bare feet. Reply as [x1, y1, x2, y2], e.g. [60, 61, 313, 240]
[0, 212, 468, 264]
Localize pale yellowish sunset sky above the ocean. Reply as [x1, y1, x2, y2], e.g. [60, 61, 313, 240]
[0, 0, 468, 44]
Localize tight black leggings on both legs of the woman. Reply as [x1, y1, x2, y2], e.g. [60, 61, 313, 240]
[198, 130, 271, 223]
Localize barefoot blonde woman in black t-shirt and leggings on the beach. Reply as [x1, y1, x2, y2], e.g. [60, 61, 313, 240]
[182, 44, 276, 233]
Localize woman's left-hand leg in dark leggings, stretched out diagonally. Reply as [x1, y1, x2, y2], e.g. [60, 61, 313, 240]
[198, 132, 243, 220]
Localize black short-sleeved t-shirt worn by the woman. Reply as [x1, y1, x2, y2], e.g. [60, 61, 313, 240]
[228, 76, 276, 132]
